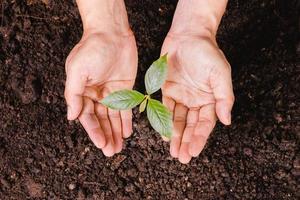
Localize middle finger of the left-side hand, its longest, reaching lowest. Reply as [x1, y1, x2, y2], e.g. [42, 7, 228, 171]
[96, 103, 115, 157]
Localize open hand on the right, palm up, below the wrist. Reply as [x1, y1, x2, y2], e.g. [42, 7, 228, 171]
[162, 33, 234, 163]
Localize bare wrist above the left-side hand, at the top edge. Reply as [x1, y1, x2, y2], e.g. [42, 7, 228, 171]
[76, 0, 132, 35]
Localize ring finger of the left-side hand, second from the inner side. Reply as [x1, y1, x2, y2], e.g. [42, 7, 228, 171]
[108, 108, 123, 153]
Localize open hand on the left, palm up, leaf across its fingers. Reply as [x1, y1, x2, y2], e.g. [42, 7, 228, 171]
[65, 31, 137, 156]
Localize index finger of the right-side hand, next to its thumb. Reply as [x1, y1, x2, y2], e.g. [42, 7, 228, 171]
[189, 104, 217, 157]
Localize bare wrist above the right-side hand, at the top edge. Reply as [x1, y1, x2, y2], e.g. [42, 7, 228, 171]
[170, 0, 227, 37]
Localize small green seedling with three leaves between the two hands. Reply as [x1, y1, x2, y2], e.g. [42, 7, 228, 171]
[100, 54, 173, 138]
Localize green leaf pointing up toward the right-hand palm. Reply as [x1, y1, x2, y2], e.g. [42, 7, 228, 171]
[145, 54, 168, 94]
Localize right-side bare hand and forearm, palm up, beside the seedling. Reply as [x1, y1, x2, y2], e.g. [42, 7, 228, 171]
[162, 0, 234, 163]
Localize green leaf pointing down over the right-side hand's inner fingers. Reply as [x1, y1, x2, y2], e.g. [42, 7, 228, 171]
[147, 99, 173, 138]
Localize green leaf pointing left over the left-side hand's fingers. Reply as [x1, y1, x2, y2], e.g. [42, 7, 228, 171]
[100, 90, 144, 110]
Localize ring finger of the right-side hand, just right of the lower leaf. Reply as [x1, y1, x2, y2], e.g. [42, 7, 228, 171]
[170, 104, 188, 158]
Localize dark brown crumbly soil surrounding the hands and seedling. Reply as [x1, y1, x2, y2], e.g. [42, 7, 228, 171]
[0, 0, 300, 200]
